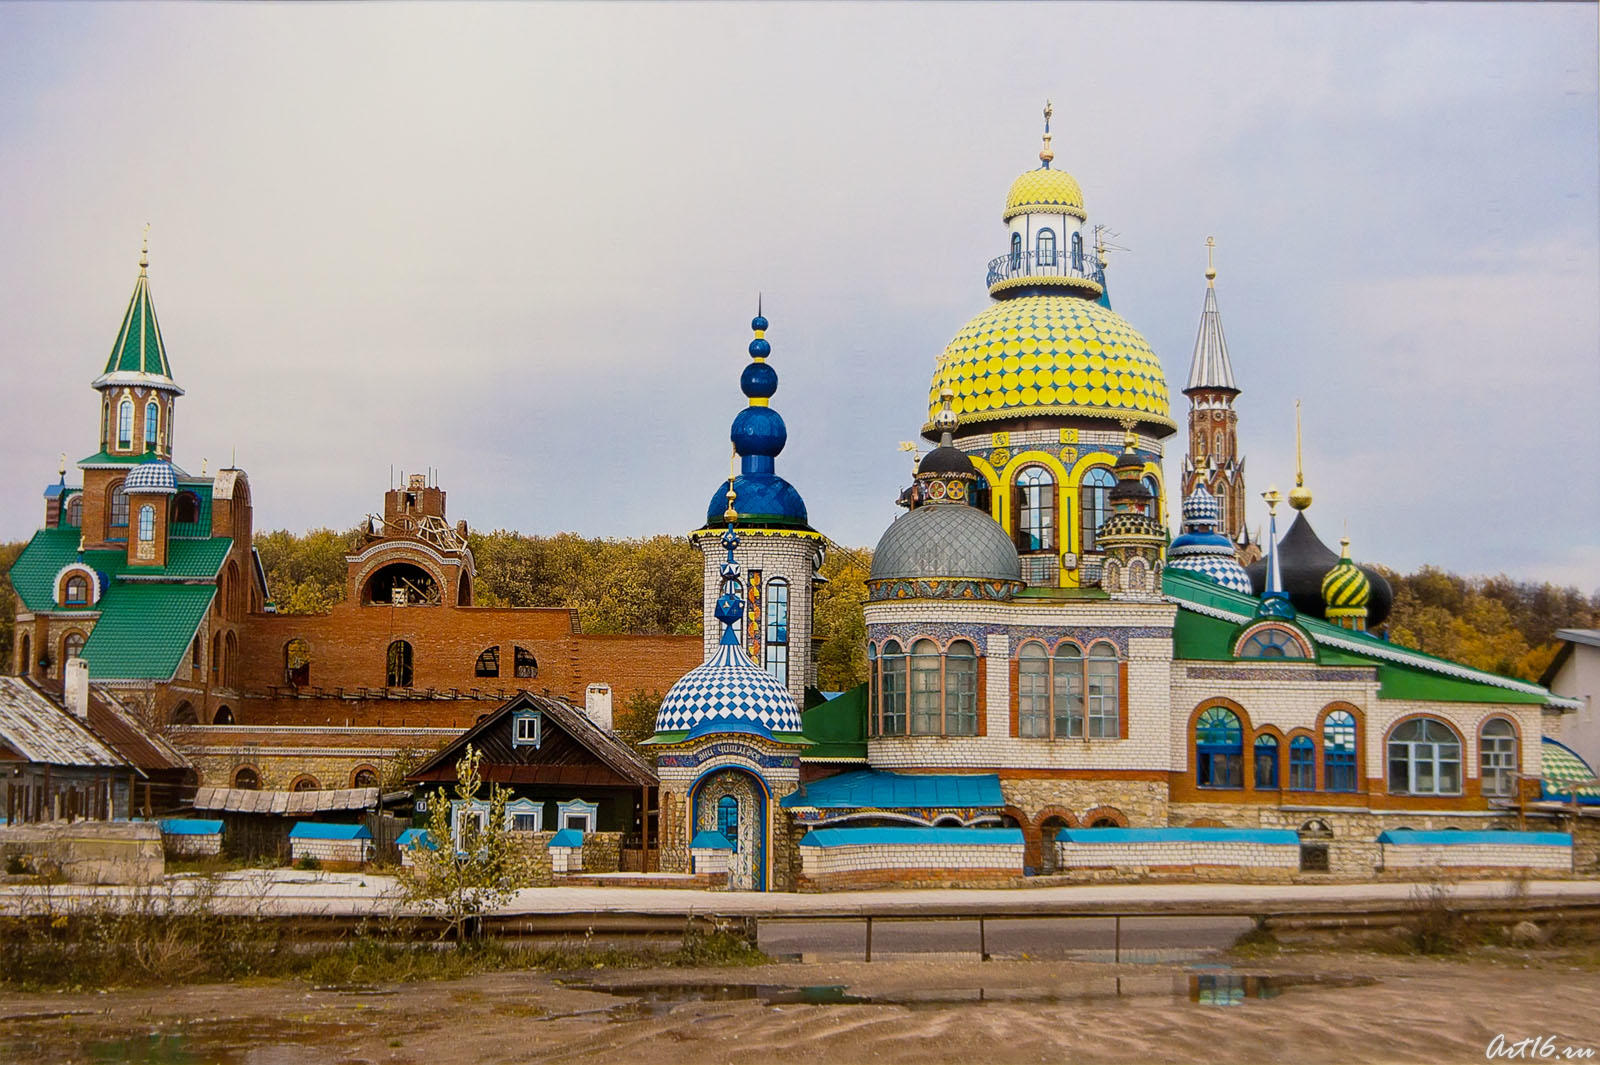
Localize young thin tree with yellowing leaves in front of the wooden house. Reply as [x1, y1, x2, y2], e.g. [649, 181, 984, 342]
[400, 744, 533, 943]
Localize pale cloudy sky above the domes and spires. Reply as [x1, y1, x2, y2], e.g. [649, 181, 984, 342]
[0, 3, 1600, 592]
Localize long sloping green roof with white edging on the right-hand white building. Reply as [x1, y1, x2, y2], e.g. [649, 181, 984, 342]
[1162, 568, 1552, 705]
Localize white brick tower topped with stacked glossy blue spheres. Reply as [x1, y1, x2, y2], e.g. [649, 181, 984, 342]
[693, 313, 826, 707]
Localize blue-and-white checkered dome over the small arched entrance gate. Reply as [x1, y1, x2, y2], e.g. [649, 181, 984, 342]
[656, 628, 800, 739]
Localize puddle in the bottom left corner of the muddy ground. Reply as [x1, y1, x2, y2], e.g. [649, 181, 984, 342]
[0, 1022, 353, 1065]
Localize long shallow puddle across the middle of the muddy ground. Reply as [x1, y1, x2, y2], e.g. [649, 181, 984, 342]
[582, 972, 1378, 1020]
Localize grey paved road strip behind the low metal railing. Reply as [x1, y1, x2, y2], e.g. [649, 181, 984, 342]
[758, 918, 1251, 961]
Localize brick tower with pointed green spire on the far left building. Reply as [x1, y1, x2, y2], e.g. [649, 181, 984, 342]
[78, 225, 184, 546]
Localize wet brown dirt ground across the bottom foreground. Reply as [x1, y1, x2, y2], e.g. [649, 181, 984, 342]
[0, 953, 1600, 1065]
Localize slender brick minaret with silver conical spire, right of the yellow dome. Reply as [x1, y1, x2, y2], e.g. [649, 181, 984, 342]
[1184, 237, 1254, 543]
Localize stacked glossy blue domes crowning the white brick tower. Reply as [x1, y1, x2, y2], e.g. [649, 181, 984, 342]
[706, 308, 811, 529]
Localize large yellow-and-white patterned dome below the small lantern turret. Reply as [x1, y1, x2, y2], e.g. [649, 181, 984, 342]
[925, 296, 1178, 437]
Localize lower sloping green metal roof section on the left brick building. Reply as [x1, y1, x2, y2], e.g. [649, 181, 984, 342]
[83, 582, 216, 681]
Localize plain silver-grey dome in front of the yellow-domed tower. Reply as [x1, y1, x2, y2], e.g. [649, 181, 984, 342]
[867, 504, 1022, 582]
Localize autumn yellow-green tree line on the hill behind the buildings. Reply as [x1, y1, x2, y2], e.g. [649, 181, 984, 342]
[0, 528, 1600, 691]
